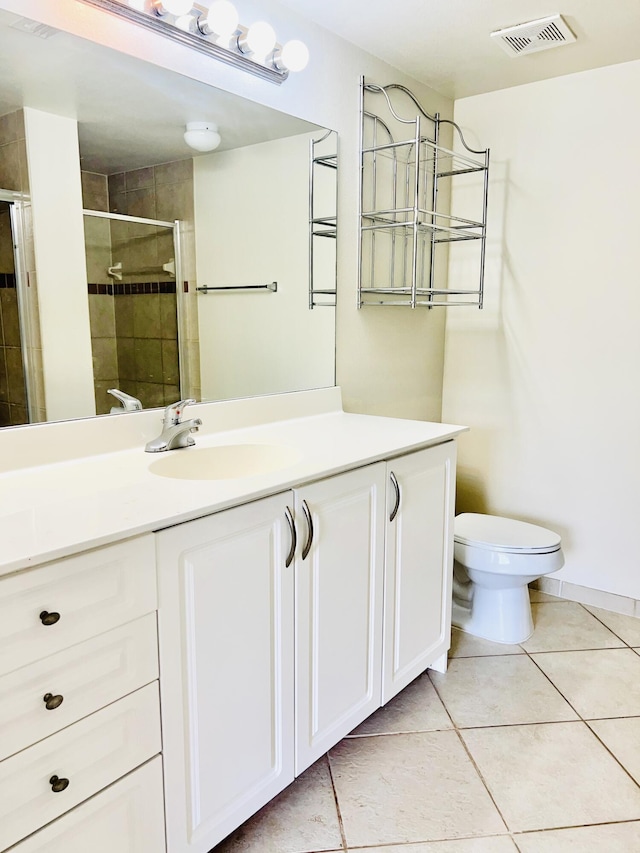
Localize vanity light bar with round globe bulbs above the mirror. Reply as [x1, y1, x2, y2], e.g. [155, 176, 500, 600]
[78, 0, 309, 84]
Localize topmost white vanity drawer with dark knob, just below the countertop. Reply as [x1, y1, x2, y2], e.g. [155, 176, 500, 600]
[0, 534, 157, 675]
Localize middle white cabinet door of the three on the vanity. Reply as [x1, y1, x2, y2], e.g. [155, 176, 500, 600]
[296, 463, 386, 775]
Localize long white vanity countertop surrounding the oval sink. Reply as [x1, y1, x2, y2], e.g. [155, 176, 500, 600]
[0, 390, 466, 575]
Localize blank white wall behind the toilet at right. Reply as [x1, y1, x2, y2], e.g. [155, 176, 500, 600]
[443, 62, 640, 598]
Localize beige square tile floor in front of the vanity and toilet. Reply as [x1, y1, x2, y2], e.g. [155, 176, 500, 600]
[215, 591, 640, 853]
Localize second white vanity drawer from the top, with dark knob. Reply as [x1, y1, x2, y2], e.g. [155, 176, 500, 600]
[0, 613, 158, 761]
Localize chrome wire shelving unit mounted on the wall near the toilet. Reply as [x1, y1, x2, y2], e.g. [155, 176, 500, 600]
[358, 78, 489, 308]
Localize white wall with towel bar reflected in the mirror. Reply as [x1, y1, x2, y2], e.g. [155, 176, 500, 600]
[193, 133, 335, 400]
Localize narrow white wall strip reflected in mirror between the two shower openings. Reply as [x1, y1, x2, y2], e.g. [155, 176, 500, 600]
[24, 107, 96, 420]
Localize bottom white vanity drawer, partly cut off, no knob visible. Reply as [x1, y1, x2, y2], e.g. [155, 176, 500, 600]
[5, 756, 166, 853]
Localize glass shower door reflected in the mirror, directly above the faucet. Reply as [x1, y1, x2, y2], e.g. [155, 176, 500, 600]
[84, 210, 182, 414]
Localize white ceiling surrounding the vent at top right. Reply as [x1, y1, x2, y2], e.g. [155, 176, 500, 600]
[280, 0, 640, 98]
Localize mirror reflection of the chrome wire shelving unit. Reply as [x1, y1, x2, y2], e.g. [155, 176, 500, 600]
[309, 130, 338, 309]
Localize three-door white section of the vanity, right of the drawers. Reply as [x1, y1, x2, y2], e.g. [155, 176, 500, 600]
[157, 442, 455, 853]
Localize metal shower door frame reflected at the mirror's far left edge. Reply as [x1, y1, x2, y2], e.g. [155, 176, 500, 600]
[0, 189, 37, 423]
